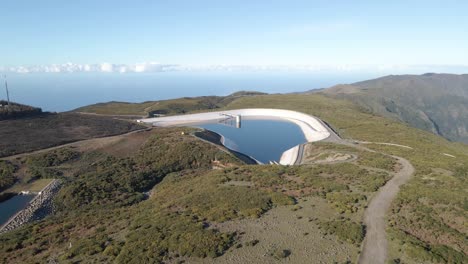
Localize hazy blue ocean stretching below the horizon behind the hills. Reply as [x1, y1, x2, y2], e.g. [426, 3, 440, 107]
[0, 71, 378, 112]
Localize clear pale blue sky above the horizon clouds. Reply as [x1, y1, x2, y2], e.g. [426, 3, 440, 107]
[0, 0, 468, 69]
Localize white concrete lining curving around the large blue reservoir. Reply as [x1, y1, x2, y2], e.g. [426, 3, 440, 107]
[138, 108, 331, 165]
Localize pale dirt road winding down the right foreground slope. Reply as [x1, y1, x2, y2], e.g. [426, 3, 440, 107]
[358, 157, 414, 264]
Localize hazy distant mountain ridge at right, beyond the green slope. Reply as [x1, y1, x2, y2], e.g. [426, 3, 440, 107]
[318, 73, 468, 143]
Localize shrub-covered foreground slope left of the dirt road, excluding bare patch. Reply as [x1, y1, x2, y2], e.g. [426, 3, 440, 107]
[0, 124, 402, 263]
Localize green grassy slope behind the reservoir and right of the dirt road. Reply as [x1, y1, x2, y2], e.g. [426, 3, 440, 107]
[228, 95, 468, 262]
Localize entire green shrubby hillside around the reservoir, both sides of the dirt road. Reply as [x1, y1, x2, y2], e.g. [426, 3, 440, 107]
[0, 94, 468, 263]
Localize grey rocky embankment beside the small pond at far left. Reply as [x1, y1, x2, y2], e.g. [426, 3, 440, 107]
[0, 180, 60, 234]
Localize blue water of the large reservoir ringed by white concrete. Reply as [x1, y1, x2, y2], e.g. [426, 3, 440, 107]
[197, 118, 307, 164]
